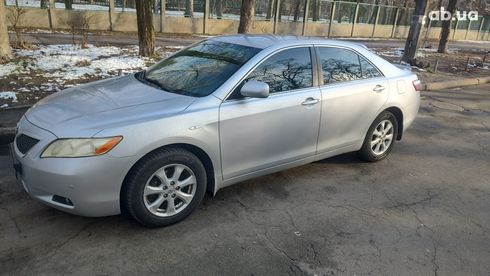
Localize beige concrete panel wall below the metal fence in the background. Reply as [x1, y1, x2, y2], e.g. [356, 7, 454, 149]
[8, 7, 490, 40]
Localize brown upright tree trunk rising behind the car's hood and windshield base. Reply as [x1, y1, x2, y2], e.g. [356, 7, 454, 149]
[136, 1, 155, 57]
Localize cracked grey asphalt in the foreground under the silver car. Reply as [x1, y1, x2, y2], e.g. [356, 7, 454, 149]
[0, 85, 490, 275]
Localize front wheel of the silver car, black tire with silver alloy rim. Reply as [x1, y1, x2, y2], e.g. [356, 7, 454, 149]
[121, 148, 207, 227]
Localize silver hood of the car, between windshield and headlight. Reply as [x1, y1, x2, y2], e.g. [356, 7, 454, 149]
[25, 75, 195, 137]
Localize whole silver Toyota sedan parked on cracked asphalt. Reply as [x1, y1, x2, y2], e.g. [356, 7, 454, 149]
[11, 35, 421, 227]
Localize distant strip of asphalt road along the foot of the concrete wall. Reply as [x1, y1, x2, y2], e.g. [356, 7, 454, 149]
[10, 32, 490, 52]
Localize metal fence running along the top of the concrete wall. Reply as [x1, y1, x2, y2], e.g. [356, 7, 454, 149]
[4, 0, 490, 40]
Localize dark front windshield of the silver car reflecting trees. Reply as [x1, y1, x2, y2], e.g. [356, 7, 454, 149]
[137, 41, 260, 97]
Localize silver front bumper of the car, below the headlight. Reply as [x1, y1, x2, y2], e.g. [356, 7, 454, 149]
[11, 118, 132, 217]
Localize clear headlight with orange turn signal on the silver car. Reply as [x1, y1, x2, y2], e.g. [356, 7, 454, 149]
[41, 136, 122, 158]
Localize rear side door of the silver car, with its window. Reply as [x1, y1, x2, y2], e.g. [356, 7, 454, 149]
[315, 47, 389, 154]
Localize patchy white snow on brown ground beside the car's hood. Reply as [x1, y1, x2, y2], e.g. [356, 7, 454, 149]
[0, 44, 183, 107]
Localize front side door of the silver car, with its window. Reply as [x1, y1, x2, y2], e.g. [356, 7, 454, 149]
[219, 47, 321, 180]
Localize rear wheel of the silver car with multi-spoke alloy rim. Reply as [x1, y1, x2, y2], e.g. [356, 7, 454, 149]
[358, 111, 398, 162]
